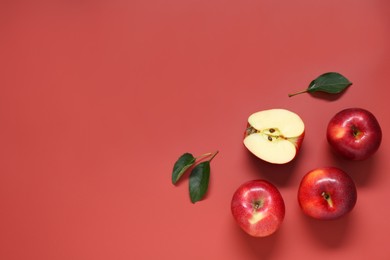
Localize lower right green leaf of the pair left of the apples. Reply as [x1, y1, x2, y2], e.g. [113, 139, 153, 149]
[190, 161, 210, 203]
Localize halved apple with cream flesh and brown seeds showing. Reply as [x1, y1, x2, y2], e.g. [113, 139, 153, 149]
[244, 109, 305, 164]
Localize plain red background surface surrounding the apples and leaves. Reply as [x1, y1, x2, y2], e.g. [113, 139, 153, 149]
[0, 0, 390, 260]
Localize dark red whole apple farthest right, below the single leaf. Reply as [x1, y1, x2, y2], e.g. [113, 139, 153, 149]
[326, 108, 382, 161]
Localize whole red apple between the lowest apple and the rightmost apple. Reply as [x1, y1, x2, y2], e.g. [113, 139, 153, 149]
[298, 167, 357, 220]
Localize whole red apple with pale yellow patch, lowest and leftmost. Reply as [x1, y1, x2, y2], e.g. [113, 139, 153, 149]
[231, 180, 285, 237]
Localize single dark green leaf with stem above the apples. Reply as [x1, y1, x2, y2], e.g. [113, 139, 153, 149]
[288, 72, 352, 97]
